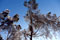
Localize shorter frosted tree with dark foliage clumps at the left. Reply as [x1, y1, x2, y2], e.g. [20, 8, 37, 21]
[0, 9, 21, 40]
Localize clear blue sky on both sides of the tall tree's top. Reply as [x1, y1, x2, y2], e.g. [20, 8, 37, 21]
[0, 0, 60, 39]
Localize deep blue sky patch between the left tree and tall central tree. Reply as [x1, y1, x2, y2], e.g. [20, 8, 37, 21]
[0, 0, 27, 28]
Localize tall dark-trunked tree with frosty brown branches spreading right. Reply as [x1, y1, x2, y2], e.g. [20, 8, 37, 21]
[24, 0, 60, 40]
